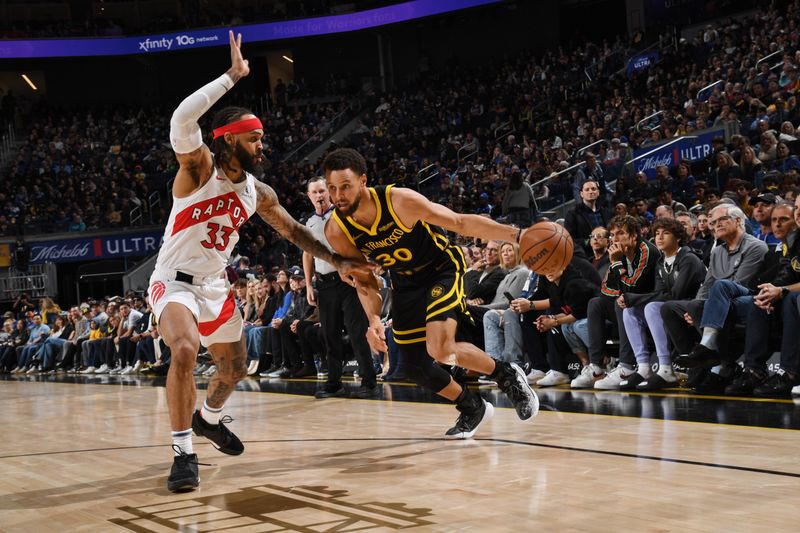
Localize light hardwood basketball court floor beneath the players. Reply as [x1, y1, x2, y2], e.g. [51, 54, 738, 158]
[0, 377, 800, 532]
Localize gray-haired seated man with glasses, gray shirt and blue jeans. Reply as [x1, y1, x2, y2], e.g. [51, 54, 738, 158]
[661, 204, 767, 368]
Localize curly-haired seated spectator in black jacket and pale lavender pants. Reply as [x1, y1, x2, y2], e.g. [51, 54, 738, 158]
[620, 218, 706, 390]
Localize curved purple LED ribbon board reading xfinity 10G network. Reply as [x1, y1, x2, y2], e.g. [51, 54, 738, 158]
[0, 0, 501, 59]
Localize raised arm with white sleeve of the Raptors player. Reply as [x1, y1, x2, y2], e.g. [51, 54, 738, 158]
[169, 31, 250, 198]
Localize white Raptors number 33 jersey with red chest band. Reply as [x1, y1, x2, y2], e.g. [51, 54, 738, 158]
[156, 167, 256, 277]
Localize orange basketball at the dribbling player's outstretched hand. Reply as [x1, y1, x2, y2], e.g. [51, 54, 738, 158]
[519, 222, 574, 274]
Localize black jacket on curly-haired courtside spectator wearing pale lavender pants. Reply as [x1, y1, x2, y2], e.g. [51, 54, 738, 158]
[624, 246, 706, 307]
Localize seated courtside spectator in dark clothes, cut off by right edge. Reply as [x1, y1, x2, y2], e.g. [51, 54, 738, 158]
[725, 201, 800, 398]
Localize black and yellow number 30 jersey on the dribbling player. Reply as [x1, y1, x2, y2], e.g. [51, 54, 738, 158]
[333, 185, 466, 278]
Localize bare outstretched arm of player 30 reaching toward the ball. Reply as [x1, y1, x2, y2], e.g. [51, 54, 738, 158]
[391, 188, 520, 242]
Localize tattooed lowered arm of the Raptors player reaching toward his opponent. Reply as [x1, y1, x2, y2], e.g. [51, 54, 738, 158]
[255, 180, 372, 279]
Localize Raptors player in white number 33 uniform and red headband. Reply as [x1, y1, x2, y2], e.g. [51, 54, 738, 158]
[149, 32, 371, 492]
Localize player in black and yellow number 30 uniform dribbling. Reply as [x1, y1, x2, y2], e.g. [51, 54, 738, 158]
[322, 148, 539, 439]
